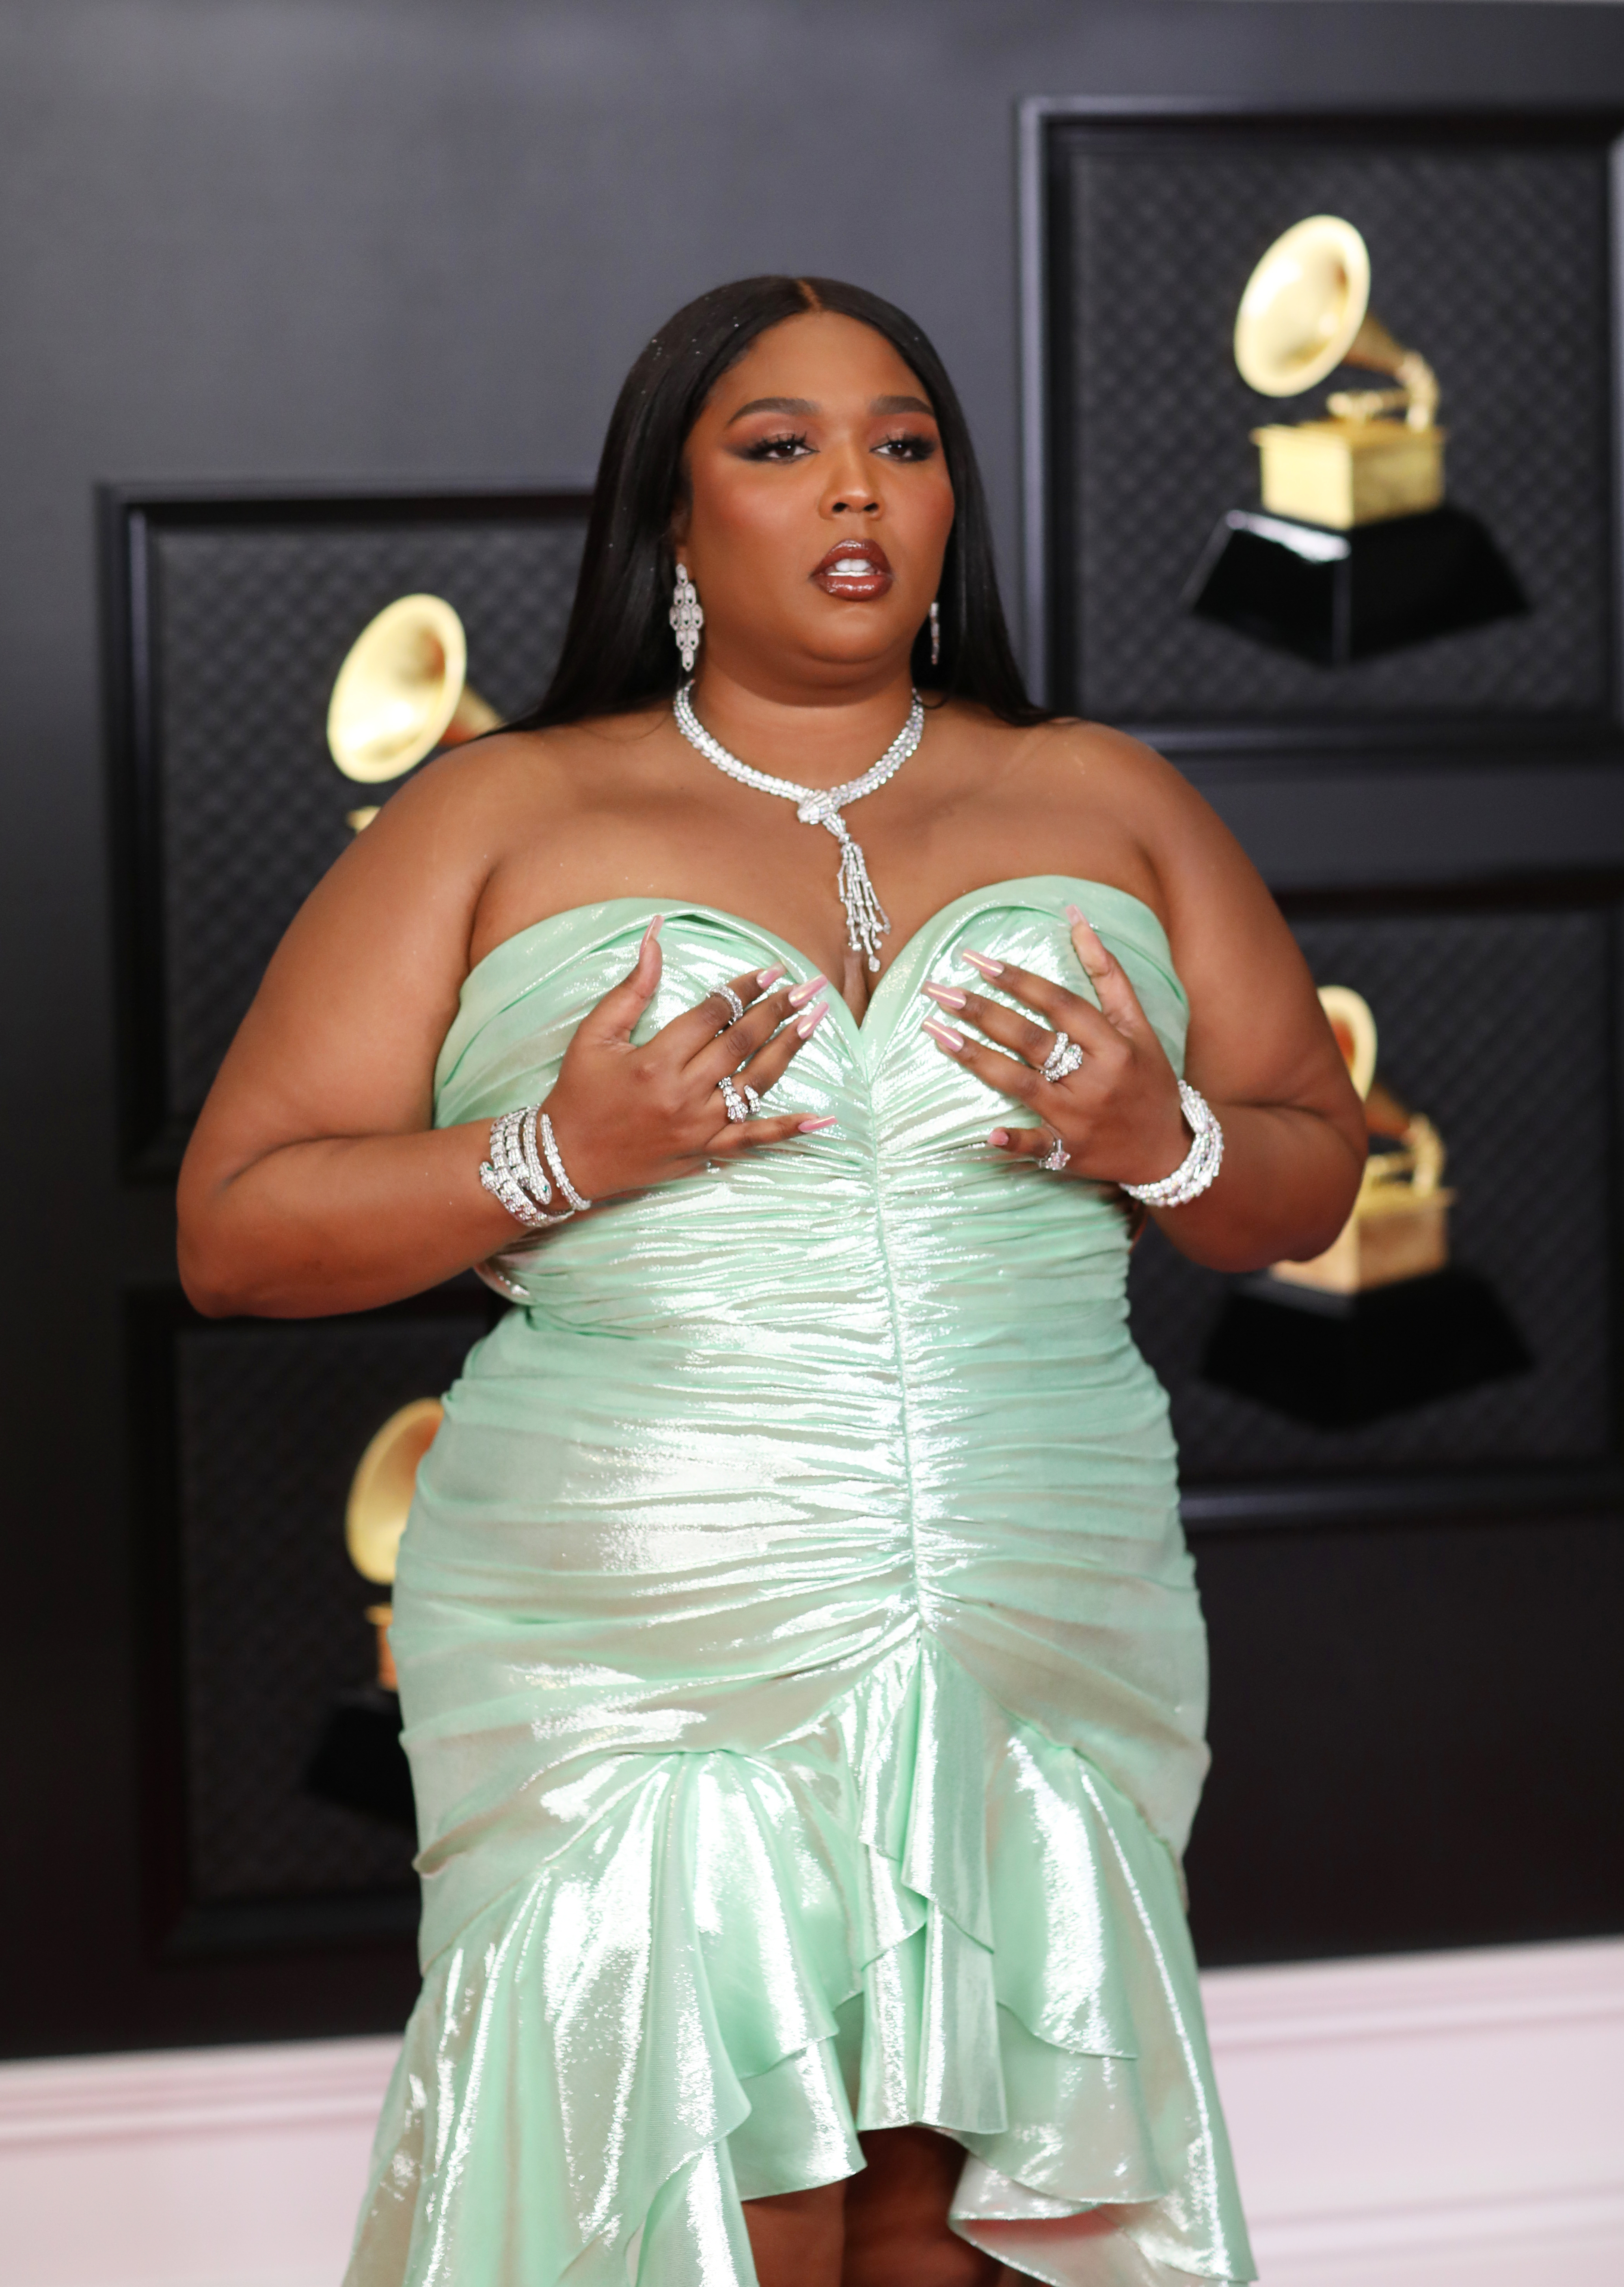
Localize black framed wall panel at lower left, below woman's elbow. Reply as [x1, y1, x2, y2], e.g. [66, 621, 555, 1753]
[126, 1278, 499, 1958]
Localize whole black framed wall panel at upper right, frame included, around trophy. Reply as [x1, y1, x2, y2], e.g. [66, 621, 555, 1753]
[1022, 98, 1624, 766]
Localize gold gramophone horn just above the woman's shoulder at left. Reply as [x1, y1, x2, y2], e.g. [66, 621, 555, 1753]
[327, 594, 501, 791]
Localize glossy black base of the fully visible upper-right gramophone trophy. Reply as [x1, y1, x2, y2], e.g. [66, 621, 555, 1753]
[1185, 506, 1528, 668]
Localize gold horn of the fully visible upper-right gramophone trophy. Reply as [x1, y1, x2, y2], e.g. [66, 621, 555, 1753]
[1235, 215, 1439, 428]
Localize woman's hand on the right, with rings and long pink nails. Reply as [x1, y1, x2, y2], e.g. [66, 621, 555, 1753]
[924, 906, 1190, 1182]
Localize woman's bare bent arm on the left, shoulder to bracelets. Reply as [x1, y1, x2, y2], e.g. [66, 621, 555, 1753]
[178, 757, 531, 1317]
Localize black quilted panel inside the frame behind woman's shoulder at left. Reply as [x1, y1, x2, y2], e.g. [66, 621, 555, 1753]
[151, 519, 583, 1121]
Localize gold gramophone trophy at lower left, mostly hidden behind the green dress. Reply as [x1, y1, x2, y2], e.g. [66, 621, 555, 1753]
[304, 1397, 446, 1825]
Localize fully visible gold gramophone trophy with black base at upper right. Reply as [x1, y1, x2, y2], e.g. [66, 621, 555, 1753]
[1185, 215, 1528, 666]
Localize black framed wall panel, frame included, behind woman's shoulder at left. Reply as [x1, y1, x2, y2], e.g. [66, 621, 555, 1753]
[103, 487, 590, 1176]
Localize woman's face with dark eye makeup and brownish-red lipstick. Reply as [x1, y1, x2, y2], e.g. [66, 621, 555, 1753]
[672, 311, 954, 688]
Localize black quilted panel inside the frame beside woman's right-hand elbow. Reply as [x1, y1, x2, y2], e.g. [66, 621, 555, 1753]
[1130, 910, 1617, 1484]
